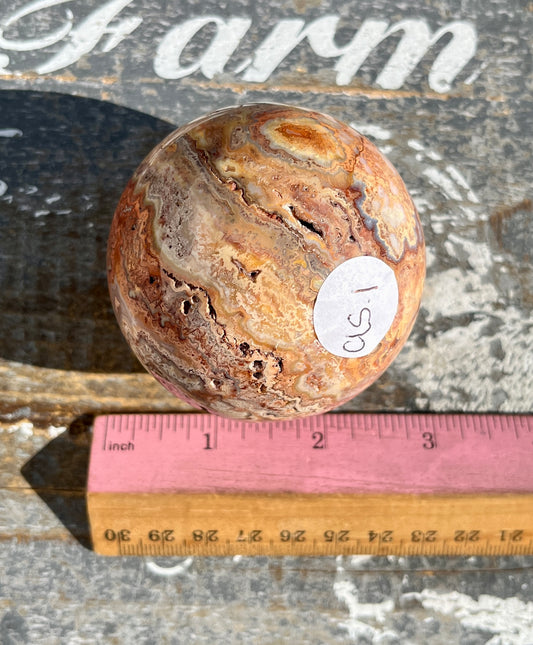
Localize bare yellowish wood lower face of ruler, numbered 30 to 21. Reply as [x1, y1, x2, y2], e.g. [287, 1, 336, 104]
[87, 491, 533, 556]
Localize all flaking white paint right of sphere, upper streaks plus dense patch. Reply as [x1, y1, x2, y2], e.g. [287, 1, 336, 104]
[372, 130, 533, 412]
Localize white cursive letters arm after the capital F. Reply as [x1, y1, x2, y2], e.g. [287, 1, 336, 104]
[160, 15, 477, 92]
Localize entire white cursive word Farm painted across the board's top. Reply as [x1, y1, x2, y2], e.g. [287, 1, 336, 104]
[0, 0, 478, 93]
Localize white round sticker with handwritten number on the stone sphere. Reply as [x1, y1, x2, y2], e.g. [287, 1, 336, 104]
[313, 256, 398, 358]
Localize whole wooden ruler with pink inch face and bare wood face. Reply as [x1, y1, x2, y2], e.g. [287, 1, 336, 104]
[87, 414, 533, 556]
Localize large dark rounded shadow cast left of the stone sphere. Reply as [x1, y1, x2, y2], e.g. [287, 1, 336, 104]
[0, 90, 175, 372]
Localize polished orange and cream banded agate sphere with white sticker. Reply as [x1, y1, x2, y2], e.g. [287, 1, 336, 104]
[108, 104, 425, 419]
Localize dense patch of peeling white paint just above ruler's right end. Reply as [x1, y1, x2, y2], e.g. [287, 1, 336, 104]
[397, 298, 533, 412]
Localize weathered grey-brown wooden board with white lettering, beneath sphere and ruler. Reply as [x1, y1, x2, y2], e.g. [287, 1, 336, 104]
[0, 0, 533, 644]
